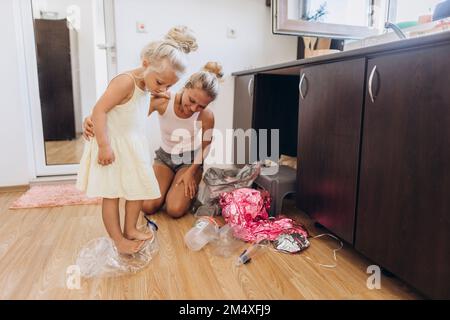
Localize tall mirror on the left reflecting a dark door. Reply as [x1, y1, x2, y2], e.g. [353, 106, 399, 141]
[31, 0, 108, 166]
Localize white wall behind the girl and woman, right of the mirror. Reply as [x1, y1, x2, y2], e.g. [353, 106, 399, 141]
[115, 0, 297, 164]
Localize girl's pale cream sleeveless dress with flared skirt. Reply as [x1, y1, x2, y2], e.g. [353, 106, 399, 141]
[77, 74, 161, 200]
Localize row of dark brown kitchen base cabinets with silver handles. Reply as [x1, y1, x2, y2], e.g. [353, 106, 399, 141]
[235, 33, 450, 299]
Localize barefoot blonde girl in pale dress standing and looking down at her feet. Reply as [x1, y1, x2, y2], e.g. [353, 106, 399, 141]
[77, 27, 197, 254]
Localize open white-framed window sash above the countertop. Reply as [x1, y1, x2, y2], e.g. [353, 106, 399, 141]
[272, 0, 387, 39]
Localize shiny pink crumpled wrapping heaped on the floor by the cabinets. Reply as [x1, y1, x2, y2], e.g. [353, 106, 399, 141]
[219, 188, 308, 242]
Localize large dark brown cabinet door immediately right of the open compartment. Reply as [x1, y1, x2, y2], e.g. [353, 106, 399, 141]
[297, 58, 365, 243]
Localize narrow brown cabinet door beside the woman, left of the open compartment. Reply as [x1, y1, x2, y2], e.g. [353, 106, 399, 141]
[233, 75, 256, 164]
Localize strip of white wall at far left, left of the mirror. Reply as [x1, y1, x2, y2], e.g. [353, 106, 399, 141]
[0, 0, 32, 187]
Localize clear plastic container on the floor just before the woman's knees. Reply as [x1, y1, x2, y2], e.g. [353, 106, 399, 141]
[184, 217, 219, 251]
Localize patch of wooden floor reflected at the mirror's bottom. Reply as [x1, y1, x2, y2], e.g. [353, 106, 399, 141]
[45, 135, 84, 165]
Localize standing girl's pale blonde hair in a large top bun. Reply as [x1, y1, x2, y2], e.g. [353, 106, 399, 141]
[141, 26, 198, 77]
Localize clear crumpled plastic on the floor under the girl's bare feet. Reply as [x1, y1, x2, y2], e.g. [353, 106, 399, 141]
[76, 223, 159, 278]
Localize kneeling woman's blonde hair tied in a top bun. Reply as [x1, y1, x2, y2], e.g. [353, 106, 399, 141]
[184, 62, 223, 100]
